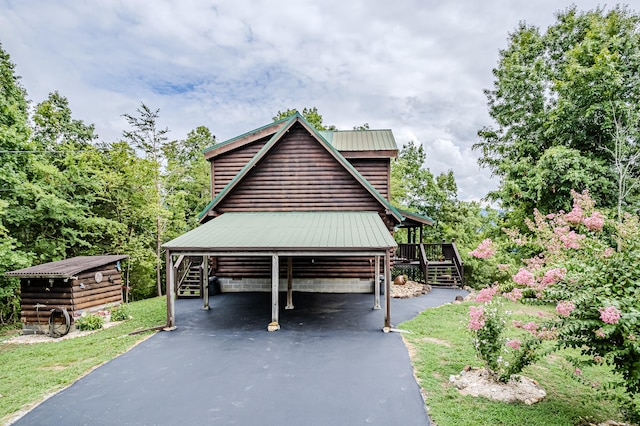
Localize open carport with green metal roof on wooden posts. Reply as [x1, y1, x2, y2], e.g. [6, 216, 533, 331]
[163, 211, 397, 331]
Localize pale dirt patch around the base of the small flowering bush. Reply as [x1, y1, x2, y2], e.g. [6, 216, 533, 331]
[449, 368, 547, 405]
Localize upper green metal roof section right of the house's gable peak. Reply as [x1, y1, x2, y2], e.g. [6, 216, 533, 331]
[318, 130, 398, 151]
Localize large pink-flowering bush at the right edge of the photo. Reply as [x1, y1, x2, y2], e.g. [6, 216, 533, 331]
[479, 192, 640, 422]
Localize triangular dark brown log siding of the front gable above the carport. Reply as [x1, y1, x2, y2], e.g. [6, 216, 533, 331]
[216, 125, 382, 213]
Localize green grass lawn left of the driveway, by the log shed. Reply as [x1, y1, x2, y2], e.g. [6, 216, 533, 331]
[0, 297, 166, 424]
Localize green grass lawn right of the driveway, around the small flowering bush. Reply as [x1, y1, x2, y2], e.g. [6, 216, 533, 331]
[400, 303, 622, 426]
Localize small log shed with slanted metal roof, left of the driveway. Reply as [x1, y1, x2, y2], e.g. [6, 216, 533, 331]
[4, 255, 129, 334]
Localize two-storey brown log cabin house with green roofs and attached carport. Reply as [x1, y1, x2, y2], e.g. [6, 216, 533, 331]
[163, 114, 458, 329]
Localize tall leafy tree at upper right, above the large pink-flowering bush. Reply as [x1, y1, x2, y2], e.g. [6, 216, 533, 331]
[474, 6, 640, 218]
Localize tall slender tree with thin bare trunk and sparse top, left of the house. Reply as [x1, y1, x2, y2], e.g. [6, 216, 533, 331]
[123, 103, 169, 296]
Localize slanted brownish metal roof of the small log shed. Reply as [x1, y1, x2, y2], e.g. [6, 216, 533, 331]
[4, 254, 129, 278]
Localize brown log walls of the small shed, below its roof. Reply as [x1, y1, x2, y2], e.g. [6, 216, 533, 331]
[20, 264, 122, 325]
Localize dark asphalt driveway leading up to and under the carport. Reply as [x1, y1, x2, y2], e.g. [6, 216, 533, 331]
[15, 289, 466, 426]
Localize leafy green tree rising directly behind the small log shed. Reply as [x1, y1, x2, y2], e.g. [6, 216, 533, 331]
[16, 92, 115, 261]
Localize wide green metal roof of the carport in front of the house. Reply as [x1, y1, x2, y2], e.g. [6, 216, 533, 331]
[163, 212, 397, 251]
